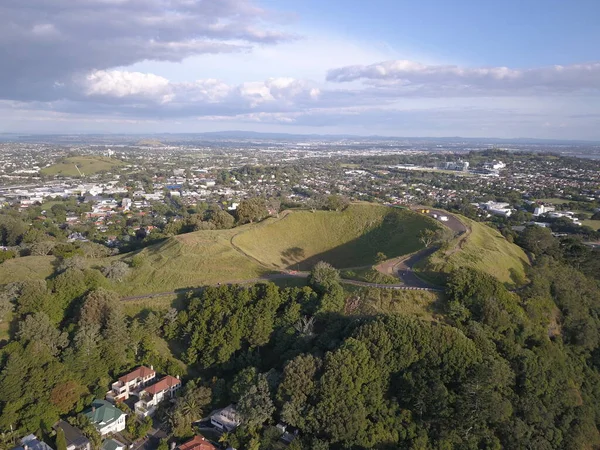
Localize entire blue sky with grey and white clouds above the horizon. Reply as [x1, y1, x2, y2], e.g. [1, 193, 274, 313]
[0, 0, 600, 141]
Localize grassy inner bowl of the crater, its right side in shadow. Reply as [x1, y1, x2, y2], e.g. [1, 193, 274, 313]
[232, 204, 439, 270]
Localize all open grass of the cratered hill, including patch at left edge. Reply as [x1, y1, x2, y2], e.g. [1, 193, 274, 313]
[0, 204, 527, 296]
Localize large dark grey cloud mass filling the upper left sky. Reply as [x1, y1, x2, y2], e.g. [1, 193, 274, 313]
[0, 0, 296, 101]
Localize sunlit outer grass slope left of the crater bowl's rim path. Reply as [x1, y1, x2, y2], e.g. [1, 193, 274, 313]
[115, 229, 268, 295]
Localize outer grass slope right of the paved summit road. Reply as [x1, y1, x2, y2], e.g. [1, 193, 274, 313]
[417, 217, 529, 285]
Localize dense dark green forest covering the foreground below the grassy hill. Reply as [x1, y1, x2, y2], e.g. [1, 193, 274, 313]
[0, 229, 600, 450]
